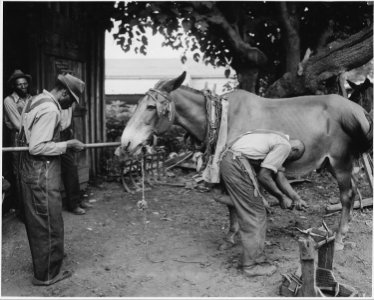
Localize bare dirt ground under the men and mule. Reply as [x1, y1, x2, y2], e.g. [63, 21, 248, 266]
[1, 169, 373, 297]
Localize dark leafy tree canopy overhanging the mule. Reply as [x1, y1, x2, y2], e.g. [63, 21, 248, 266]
[113, 1, 372, 96]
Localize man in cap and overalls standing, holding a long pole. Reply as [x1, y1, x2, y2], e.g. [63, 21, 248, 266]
[20, 74, 85, 285]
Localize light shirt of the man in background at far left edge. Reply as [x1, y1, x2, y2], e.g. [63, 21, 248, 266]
[4, 92, 31, 131]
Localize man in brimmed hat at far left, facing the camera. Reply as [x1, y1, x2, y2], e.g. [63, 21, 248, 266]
[3, 70, 31, 220]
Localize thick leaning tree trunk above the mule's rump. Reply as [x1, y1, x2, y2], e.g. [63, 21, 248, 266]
[266, 27, 373, 98]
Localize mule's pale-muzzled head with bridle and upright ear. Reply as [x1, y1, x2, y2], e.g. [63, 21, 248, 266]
[121, 72, 186, 154]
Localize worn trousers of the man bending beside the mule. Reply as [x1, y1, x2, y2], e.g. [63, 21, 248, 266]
[221, 151, 267, 266]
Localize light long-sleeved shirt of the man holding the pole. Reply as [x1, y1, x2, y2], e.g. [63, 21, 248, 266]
[21, 90, 67, 156]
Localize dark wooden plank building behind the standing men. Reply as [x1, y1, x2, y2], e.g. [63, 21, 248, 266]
[3, 1, 114, 177]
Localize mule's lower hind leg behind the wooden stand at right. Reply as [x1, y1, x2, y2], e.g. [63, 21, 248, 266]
[335, 173, 355, 251]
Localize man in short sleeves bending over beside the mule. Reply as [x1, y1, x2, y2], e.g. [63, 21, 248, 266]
[220, 130, 307, 276]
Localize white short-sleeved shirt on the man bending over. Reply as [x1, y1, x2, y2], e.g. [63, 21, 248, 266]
[231, 132, 291, 173]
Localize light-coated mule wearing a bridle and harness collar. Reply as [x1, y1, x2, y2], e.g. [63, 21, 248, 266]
[121, 72, 372, 248]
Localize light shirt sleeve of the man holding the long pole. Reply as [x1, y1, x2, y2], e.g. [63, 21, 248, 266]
[29, 111, 67, 156]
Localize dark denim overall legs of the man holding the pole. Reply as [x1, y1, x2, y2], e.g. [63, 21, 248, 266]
[20, 152, 64, 282]
